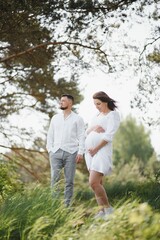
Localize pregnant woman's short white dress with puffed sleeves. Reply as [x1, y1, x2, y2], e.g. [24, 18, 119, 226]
[85, 111, 120, 175]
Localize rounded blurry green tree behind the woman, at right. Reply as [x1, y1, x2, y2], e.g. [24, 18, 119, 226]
[114, 116, 153, 165]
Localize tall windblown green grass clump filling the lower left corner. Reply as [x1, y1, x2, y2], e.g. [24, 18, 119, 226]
[0, 186, 86, 240]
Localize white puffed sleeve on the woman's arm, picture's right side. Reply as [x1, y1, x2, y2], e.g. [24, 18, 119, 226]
[103, 112, 120, 142]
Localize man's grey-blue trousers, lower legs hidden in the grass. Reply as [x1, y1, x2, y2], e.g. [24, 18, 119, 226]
[49, 149, 77, 206]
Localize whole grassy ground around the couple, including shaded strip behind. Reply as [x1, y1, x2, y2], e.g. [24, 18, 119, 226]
[0, 167, 160, 240]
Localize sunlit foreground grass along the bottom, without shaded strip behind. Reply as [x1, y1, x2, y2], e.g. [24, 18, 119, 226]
[0, 185, 160, 240]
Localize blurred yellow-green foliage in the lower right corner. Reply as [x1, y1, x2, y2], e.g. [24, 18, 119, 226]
[80, 202, 160, 240]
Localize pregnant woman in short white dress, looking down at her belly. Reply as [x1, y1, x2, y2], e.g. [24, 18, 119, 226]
[85, 91, 120, 218]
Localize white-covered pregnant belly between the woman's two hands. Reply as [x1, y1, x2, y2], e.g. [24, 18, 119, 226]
[85, 131, 102, 149]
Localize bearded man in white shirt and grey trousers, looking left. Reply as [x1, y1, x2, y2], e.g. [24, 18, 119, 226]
[47, 94, 85, 206]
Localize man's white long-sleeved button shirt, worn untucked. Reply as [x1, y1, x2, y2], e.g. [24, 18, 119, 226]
[46, 111, 85, 154]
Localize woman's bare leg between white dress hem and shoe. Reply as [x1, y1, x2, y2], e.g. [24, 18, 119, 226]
[89, 171, 110, 208]
